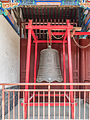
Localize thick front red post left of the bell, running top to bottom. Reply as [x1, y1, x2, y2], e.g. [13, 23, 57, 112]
[24, 21, 32, 119]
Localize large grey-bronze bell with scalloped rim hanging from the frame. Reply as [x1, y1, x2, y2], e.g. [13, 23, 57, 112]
[37, 46, 63, 82]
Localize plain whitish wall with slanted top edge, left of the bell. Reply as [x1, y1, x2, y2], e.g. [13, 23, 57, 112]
[0, 15, 20, 88]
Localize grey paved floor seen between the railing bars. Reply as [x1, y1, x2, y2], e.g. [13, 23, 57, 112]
[5, 99, 89, 120]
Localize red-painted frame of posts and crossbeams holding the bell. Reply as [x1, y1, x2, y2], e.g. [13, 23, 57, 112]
[24, 20, 90, 120]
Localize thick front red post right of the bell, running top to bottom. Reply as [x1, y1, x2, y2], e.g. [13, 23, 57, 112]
[67, 20, 74, 119]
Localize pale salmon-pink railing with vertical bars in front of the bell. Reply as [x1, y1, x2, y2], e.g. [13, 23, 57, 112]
[0, 83, 90, 120]
